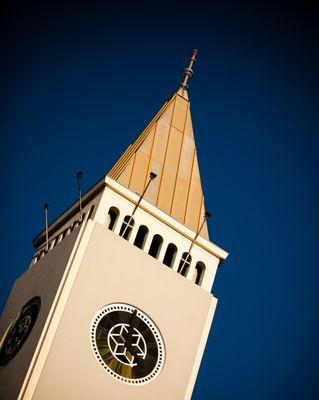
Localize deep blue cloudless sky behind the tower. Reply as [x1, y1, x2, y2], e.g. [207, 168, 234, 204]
[0, 1, 319, 400]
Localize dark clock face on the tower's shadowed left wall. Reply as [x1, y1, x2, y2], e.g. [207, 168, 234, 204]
[0, 297, 41, 366]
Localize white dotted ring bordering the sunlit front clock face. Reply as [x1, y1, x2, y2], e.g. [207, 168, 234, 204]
[90, 303, 165, 385]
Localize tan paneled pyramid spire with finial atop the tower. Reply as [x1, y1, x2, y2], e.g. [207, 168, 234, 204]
[108, 50, 208, 239]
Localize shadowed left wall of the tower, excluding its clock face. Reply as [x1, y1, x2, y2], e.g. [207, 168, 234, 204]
[0, 229, 79, 400]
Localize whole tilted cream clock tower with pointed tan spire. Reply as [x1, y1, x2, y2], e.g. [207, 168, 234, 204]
[0, 50, 227, 400]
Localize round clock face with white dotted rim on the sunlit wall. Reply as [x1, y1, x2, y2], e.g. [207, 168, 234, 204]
[91, 303, 165, 385]
